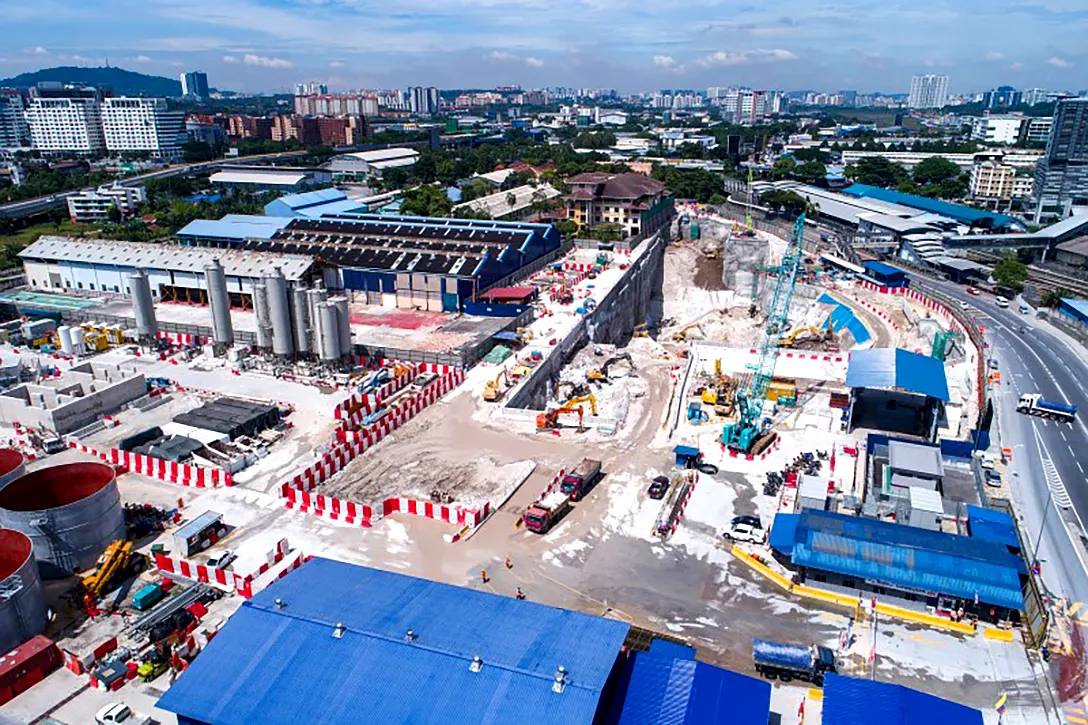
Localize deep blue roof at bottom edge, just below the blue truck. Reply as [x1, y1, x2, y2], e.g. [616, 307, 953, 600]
[823, 674, 982, 725]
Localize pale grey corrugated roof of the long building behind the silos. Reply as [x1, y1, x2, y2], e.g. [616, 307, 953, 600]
[18, 236, 313, 280]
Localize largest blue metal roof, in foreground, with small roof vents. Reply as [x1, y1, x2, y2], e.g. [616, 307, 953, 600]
[159, 558, 629, 725]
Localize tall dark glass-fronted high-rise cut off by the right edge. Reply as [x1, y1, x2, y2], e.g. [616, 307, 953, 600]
[1033, 98, 1088, 219]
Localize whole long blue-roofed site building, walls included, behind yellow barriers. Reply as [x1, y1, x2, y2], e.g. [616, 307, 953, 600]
[768, 508, 1026, 620]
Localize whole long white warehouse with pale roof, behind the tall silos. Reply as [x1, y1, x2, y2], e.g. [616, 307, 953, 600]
[18, 236, 321, 307]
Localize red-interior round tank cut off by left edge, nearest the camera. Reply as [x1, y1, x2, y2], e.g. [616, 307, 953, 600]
[0, 529, 49, 652]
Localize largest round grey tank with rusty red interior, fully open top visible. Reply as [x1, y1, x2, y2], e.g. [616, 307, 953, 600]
[0, 463, 125, 579]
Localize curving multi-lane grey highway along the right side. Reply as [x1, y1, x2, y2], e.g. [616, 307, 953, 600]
[930, 276, 1088, 602]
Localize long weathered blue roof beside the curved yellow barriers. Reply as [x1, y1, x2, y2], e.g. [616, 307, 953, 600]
[791, 508, 1024, 610]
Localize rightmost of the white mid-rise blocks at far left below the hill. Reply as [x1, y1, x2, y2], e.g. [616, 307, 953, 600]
[101, 98, 188, 159]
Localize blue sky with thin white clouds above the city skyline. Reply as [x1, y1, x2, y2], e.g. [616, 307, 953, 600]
[0, 0, 1088, 93]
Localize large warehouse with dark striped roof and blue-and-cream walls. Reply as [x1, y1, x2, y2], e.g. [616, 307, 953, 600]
[240, 214, 560, 311]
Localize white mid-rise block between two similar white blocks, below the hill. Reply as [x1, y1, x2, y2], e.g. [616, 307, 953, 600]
[25, 83, 106, 153]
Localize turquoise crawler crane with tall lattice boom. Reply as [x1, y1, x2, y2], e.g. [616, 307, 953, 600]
[721, 213, 805, 453]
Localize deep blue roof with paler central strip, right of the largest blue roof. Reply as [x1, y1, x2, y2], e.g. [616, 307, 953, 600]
[617, 652, 770, 725]
